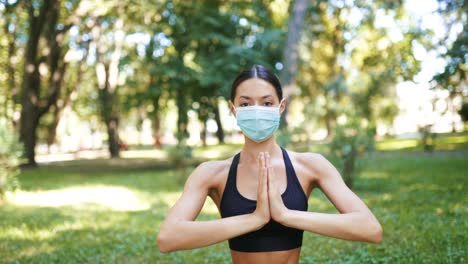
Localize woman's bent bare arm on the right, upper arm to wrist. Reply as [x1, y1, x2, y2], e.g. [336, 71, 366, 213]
[270, 154, 382, 243]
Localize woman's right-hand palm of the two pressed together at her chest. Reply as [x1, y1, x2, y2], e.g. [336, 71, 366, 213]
[266, 153, 288, 223]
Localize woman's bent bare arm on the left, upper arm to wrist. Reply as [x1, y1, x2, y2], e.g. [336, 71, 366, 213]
[158, 158, 270, 253]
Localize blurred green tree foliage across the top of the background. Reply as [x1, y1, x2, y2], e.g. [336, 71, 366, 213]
[0, 0, 467, 165]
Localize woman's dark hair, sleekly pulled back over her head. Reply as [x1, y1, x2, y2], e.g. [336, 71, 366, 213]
[231, 65, 283, 102]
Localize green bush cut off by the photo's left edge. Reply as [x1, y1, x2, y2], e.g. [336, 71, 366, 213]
[0, 118, 23, 201]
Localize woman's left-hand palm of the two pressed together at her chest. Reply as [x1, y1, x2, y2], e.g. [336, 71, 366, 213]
[254, 152, 271, 226]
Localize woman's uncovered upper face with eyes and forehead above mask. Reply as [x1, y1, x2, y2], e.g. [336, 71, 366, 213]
[229, 78, 286, 115]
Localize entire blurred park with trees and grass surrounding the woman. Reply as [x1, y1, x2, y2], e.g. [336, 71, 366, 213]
[0, 0, 468, 263]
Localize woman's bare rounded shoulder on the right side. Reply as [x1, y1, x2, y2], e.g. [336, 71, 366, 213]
[288, 150, 336, 183]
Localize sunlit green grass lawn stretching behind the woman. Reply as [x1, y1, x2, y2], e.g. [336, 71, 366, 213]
[0, 136, 468, 263]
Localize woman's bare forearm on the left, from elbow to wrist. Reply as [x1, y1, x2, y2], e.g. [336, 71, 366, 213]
[158, 214, 265, 252]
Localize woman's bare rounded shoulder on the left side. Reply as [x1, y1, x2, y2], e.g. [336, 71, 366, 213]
[185, 158, 232, 188]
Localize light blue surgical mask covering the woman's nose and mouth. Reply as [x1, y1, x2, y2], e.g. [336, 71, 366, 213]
[236, 100, 281, 143]
